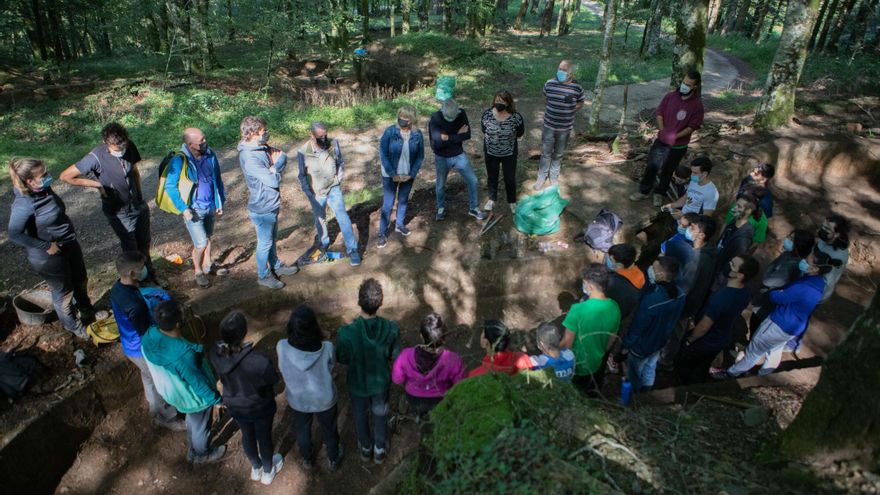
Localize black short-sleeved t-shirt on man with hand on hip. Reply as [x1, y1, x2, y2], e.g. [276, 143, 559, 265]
[76, 141, 144, 215]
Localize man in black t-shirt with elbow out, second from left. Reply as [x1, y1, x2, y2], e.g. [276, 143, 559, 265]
[60, 122, 156, 281]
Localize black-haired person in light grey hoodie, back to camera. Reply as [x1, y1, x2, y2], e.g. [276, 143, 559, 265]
[276, 306, 343, 471]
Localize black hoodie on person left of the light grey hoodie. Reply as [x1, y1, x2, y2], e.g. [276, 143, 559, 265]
[209, 342, 280, 419]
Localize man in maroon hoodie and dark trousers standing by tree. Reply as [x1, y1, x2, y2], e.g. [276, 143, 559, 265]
[629, 69, 714, 207]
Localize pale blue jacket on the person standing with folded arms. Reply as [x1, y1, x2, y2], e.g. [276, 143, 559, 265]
[238, 142, 287, 214]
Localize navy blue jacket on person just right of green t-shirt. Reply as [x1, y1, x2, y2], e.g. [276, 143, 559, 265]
[623, 284, 685, 358]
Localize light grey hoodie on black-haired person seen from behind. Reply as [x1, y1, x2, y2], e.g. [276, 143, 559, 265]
[275, 339, 336, 413]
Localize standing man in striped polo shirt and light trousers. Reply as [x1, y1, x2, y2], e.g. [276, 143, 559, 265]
[532, 60, 587, 191]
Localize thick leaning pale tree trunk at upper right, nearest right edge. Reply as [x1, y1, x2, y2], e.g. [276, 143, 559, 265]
[755, 0, 819, 128]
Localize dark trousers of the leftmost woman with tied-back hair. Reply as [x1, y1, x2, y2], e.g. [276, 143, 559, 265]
[28, 241, 92, 332]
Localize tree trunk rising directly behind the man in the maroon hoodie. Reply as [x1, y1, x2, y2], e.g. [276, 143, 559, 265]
[670, 0, 709, 87]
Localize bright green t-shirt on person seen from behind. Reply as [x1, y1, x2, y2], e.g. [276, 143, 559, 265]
[562, 299, 620, 376]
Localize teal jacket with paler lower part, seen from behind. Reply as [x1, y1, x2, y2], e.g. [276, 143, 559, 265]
[141, 325, 220, 414]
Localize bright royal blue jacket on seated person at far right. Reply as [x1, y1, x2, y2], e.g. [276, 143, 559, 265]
[770, 275, 825, 337]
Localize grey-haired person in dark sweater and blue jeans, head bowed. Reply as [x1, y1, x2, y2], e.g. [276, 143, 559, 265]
[428, 98, 485, 222]
